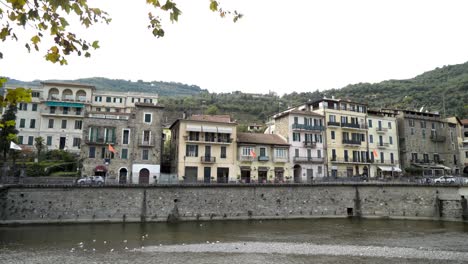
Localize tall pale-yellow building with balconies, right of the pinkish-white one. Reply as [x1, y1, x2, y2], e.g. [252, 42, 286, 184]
[306, 98, 370, 178]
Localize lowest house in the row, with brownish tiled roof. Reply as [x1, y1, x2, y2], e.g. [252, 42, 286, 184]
[236, 133, 292, 183]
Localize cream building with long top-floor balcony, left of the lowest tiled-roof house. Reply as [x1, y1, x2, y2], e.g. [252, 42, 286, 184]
[170, 115, 237, 183]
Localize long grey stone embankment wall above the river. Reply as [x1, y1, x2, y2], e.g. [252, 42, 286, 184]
[0, 184, 468, 224]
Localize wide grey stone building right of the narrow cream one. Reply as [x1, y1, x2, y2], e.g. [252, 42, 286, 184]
[395, 110, 461, 176]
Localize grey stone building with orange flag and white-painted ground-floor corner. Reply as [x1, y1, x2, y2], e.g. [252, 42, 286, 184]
[81, 102, 163, 184]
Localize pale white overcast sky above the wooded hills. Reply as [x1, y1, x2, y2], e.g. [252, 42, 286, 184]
[0, 0, 468, 94]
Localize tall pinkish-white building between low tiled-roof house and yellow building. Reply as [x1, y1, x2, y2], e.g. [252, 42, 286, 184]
[265, 108, 326, 183]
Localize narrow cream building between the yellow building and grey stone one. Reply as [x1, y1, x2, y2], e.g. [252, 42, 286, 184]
[367, 109, 402, 178]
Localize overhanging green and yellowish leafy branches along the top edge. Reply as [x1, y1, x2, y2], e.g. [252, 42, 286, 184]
[0, 0, 242, 65]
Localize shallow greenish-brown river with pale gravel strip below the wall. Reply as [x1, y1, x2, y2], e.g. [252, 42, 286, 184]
[0, 219, 468, 264]
